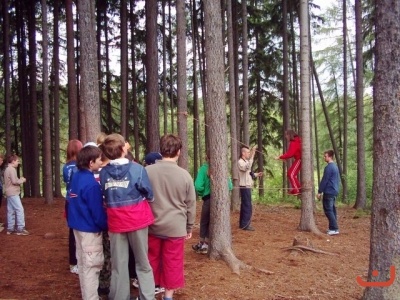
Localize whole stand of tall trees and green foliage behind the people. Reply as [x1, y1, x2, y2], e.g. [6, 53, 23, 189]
[0, 0, 400, 299]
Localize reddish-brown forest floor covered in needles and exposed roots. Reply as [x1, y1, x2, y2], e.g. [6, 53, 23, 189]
[0, 199, 370, 300]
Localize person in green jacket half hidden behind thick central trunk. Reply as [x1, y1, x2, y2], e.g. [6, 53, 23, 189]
[192, 154, 233, 254]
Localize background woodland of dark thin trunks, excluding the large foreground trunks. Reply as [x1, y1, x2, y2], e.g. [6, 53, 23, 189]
[0, 0, 373, 204]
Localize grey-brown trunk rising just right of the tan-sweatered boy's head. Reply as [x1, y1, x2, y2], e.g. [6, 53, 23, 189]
[176, 0, 189, 170]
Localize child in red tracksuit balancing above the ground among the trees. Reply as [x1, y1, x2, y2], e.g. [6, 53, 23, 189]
[275, 129, 301, 196]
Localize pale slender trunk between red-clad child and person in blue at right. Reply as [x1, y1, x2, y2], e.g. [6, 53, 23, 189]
[299, 0, 319, 233]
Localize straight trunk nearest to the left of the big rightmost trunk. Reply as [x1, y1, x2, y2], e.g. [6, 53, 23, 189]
[354, 0, 367, 209]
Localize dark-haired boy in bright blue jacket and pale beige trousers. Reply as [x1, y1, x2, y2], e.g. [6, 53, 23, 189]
[67, 146, 107, 300]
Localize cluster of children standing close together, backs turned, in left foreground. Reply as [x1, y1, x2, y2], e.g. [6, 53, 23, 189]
[63, 134, 196, 300]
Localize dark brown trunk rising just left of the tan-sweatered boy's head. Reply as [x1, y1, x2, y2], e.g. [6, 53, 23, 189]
[145, 0, 160, 152]
